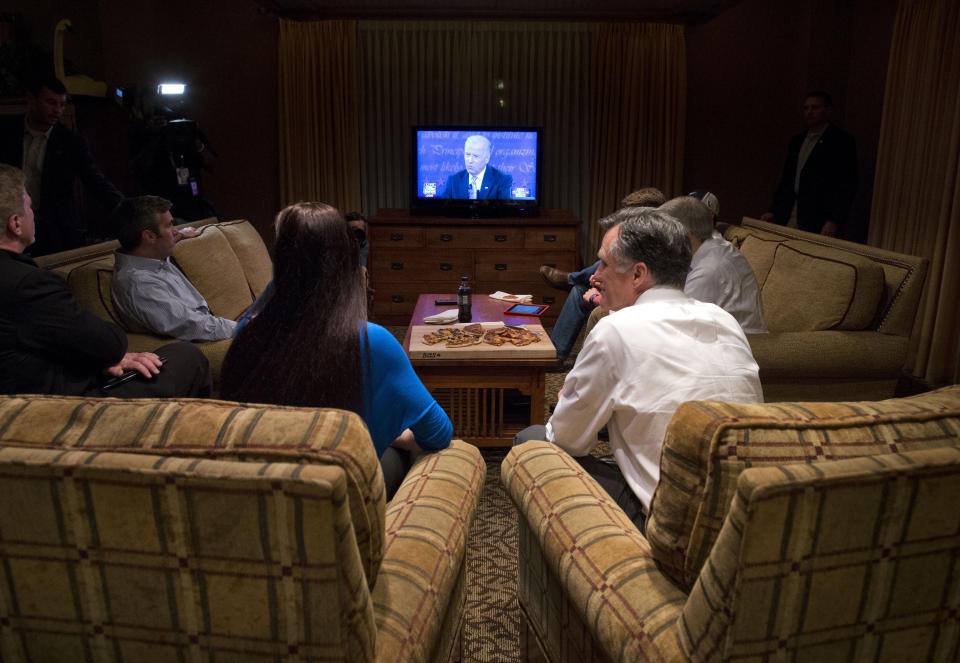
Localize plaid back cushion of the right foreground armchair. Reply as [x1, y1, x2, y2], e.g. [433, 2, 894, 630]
[647, 385, 960, 590]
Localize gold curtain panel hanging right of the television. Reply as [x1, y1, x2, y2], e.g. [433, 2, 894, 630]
[588, 23, 687, 251]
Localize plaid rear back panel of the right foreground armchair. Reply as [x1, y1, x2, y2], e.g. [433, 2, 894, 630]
[679, 447, 960, 663]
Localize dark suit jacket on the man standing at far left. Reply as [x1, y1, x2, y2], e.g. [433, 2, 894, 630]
[0, 115, 123, 256]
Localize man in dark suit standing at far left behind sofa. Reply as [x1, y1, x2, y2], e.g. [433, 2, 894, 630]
[0, 77, 123, 256]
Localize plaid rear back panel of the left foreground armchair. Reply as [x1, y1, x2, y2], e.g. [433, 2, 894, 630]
[0, 447, 375, 663]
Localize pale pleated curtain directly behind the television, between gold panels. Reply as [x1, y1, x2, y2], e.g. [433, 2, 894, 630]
[357, 21, 592, 237]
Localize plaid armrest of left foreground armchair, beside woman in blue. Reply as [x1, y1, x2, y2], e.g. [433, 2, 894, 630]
[373, 440, 486, 663]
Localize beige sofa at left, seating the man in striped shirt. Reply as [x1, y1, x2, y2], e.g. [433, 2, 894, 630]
[37, 219, 273, 390]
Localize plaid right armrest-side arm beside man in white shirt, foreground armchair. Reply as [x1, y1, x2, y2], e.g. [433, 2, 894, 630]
[501, 442, 687, 661]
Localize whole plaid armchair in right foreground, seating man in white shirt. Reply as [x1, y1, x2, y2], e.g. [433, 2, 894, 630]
[501, 386, 960, 663]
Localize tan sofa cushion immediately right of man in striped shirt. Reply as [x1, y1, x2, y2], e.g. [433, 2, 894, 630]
[173, 226, 253, 320]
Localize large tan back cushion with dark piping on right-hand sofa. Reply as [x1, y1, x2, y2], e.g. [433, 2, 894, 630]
[761, 240, 883, 332]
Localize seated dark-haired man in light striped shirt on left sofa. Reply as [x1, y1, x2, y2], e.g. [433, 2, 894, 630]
[110, 196, 237, 341]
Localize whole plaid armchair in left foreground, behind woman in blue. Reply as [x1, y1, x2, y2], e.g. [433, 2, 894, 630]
[0, 396, 486, 663]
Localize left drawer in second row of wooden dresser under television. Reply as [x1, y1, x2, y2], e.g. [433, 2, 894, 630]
[371, 249, 474, 282]
